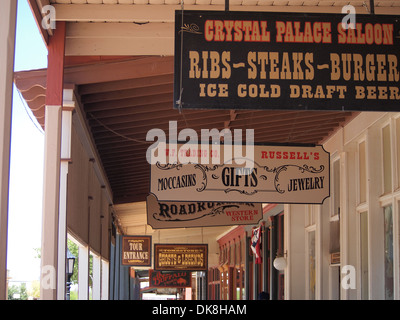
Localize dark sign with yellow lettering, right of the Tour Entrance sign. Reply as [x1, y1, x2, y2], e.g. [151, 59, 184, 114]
[154, 244, 208, 271]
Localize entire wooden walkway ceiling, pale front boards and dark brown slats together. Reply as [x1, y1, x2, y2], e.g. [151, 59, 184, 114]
[19, 0, 400, 204]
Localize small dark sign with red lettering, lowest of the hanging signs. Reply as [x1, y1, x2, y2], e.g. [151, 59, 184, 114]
[149, 270, 192, 288]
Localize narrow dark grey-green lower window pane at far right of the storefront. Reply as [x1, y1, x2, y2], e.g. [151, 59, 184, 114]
[384, 206, 394, 300]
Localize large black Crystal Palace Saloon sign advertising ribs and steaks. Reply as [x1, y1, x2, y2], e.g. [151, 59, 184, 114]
[174, 11, 400, 111]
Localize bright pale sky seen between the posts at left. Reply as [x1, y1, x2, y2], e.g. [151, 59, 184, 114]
[7, 0, 47, 285]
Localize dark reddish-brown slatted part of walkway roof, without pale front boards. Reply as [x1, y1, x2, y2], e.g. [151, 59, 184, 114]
[15, 56, 355, 204]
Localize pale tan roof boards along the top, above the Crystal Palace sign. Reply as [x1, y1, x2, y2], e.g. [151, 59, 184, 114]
[29, 0, 400, 56]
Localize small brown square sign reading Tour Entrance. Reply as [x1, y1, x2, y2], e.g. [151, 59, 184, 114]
[121, 236, 151, 267]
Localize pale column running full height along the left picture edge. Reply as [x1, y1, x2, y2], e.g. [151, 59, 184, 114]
[0, 0, 17, 300]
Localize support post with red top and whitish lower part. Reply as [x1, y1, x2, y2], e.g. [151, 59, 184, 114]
[40, 22, 66, 300]
